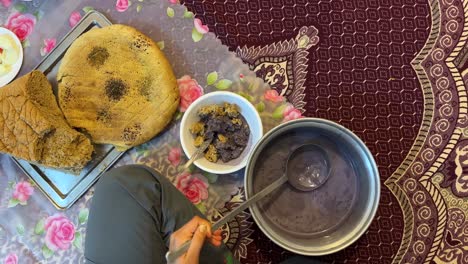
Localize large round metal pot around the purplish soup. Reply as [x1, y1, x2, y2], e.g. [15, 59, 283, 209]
[244, 118, 380, 256]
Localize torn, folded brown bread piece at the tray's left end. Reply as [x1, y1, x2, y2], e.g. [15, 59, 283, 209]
[0, 71, 93, 172]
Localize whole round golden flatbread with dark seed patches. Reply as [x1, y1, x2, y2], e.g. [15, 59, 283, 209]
[57, 25, 179, 150]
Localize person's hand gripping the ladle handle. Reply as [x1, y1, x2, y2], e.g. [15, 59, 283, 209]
[169, 216, 222, 264]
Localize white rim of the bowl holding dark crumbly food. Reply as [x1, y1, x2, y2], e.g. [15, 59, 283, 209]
[179, 91, 263, 174]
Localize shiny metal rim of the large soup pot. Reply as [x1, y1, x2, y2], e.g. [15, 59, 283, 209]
[244, 117, 381, 256]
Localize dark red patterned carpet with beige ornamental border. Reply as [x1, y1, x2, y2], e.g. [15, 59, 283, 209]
[184, 0, 468, 264]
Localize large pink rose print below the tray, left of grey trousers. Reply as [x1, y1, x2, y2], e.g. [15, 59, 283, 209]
[44, 214, 76, 251]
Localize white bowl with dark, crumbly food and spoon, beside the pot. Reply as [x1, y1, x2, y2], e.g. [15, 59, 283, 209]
[180, 91, 263, 174]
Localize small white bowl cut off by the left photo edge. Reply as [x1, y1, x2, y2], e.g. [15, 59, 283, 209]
[0, 27, 23, 88]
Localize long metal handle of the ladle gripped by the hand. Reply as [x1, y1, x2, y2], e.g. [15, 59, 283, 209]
[166, 174, 288, 264]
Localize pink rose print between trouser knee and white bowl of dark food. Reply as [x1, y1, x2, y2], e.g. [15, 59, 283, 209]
[176, 172, 209, 204]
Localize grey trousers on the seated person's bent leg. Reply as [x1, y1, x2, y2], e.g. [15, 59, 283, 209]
[85, 165, 229, 264]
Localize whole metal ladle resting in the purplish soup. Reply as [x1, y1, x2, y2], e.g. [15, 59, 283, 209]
[166, 143, 331, 264]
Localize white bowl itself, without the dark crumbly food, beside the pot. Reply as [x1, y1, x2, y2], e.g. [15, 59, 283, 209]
[180, 92, 263, 174]
